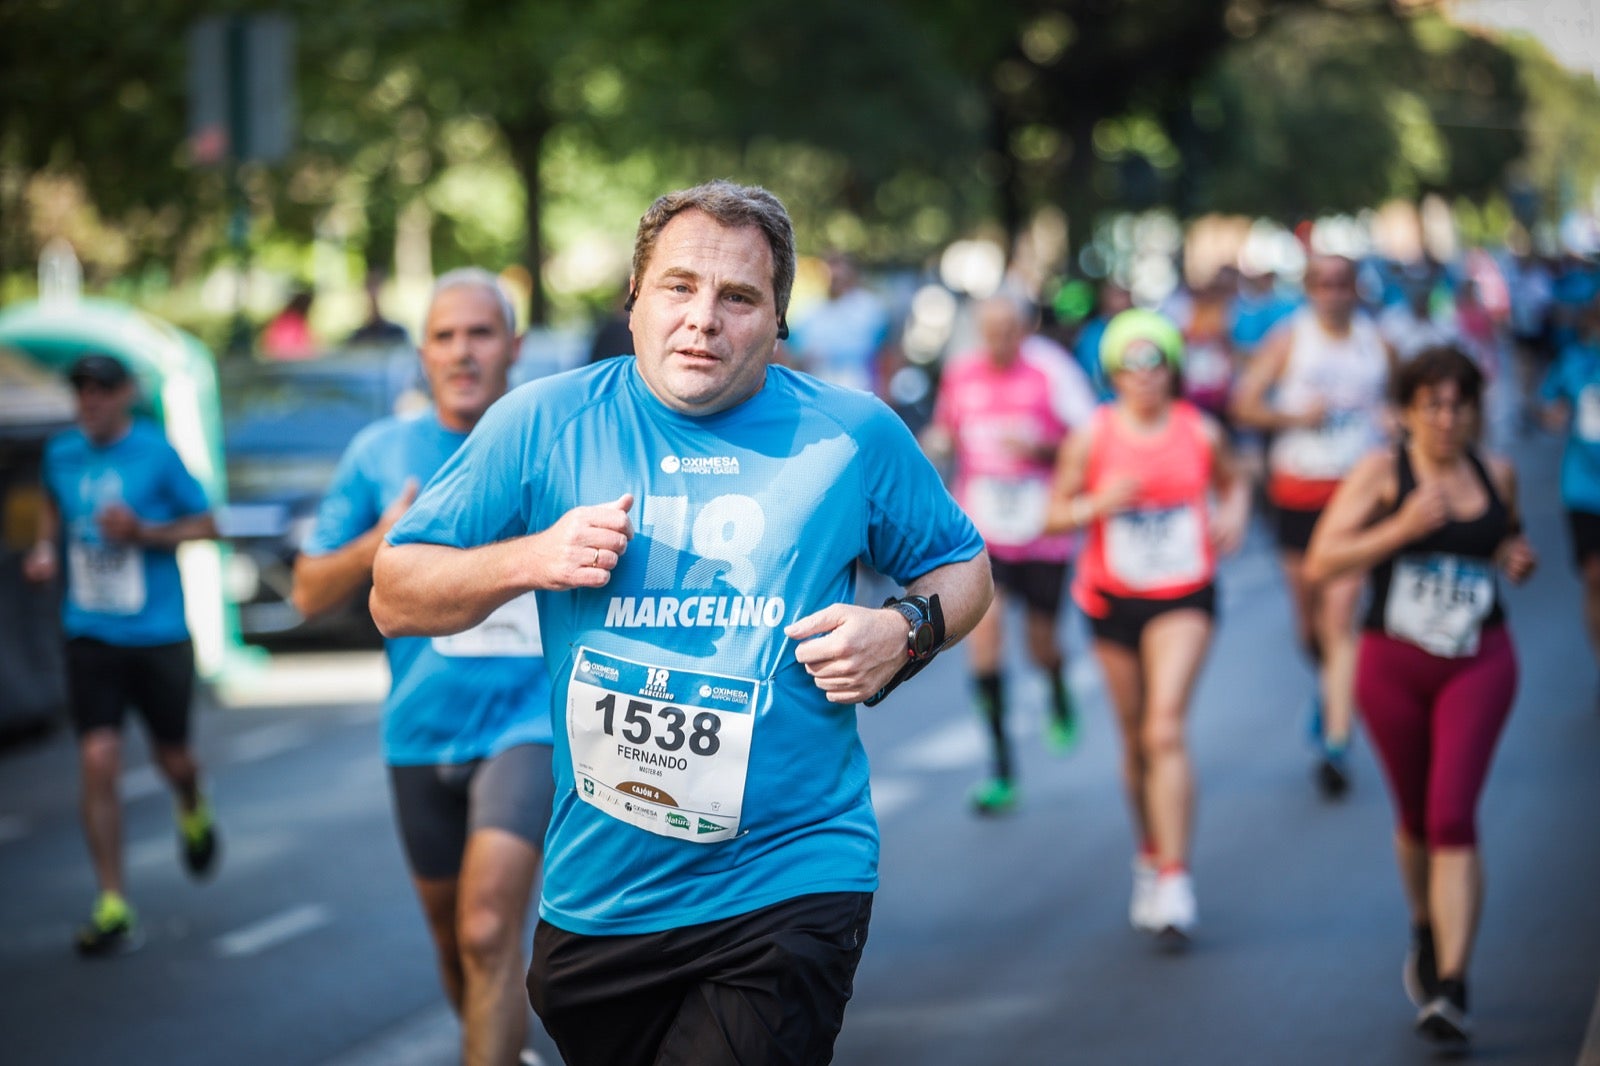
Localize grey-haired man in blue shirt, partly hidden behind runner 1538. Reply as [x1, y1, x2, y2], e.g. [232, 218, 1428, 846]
[294, 269, 554, 1064]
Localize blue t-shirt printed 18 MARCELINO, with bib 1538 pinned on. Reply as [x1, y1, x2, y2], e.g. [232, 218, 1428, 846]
[389, 357, 982, 935]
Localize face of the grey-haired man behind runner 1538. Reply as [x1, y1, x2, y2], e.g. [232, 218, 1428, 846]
[421, 285, 517, 432]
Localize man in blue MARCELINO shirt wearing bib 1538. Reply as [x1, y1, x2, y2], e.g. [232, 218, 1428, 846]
[373, 182, 992, 1066]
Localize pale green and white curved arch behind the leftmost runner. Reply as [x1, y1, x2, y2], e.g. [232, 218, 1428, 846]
[0, 298, 242, 680]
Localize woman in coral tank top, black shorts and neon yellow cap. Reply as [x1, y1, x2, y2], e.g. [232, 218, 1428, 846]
[1048, 309, 1250, 948]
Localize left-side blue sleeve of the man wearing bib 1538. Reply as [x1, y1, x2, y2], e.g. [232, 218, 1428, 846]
[386, 386, 542, 547]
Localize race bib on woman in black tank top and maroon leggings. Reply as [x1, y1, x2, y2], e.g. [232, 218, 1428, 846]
[1384, 554, 1494, 659]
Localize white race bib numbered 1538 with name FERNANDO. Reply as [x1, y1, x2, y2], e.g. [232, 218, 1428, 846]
[566, 647, 762, 844]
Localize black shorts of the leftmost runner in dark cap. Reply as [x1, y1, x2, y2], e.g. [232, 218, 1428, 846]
[67, 637, 195, 747]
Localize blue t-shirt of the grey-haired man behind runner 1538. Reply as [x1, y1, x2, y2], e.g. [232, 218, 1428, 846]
[301, 411, 550, 767]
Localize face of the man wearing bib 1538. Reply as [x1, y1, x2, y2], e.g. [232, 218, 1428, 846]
[629, 210, 778, 415]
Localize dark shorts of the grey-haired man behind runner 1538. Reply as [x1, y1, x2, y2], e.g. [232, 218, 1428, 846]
[389, 744, 555, 880]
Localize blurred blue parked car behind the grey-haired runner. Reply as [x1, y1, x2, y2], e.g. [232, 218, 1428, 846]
[218, 347, 427, 647]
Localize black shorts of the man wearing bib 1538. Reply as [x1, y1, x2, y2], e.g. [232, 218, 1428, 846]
[528, 892, 872, 1066]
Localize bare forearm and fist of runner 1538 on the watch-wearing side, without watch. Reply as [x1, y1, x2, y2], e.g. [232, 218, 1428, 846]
[784, 552, 994, 703]
